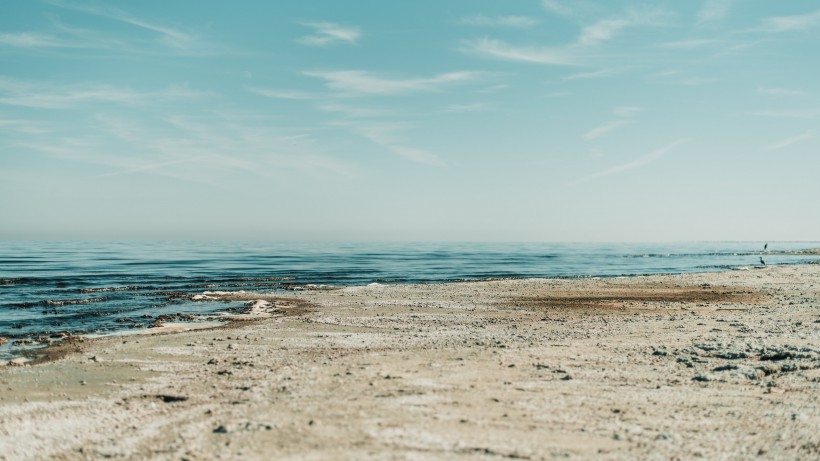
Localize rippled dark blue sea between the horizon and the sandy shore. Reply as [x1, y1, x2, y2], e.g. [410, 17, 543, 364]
[0, 241, 820, 359]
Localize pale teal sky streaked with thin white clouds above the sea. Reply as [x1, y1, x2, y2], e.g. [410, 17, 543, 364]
[0, 0, 820, 242]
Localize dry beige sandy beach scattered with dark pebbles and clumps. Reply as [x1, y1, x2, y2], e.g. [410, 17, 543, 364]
[0, 265, 820, 460]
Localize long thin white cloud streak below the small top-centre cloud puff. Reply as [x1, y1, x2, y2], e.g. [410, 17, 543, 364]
[304, 70, 482, 95]
